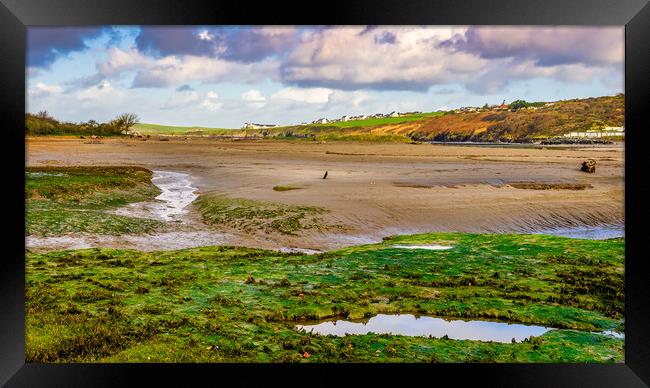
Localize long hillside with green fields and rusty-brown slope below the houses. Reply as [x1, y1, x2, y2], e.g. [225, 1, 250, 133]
[129, 94, 625, 142]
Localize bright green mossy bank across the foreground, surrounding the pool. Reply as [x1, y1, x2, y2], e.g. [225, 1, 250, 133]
[26, 233, 624, 362]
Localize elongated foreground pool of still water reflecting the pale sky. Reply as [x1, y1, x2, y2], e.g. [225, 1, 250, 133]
[296, 314, 553, 342]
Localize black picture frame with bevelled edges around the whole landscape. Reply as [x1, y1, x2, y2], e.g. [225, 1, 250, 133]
[0, 0, 650, 387]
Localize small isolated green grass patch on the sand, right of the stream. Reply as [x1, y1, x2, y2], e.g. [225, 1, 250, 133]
[194, 194, 328, 235]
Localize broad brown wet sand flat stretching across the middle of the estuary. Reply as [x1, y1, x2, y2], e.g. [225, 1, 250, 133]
[27, 137, 624, 249]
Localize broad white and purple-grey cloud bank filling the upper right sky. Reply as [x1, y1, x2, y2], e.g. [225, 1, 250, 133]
[281, 26, 623, 93]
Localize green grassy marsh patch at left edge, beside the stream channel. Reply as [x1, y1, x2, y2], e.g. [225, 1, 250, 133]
[25, 167, 164, 236]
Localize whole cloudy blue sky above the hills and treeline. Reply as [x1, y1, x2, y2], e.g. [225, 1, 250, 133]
[26, 26, 624, 128]
